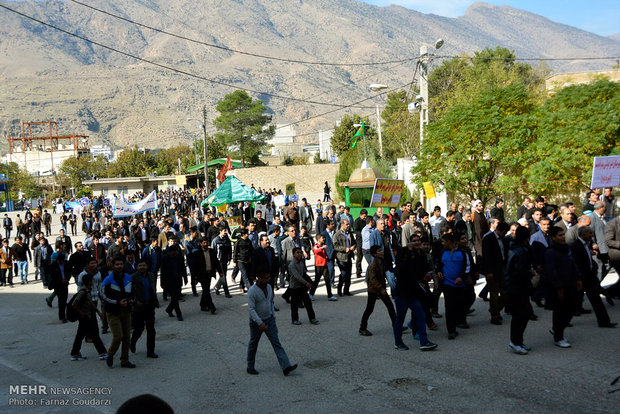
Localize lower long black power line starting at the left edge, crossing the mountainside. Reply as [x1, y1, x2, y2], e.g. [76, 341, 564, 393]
[0, 4, 370, 109]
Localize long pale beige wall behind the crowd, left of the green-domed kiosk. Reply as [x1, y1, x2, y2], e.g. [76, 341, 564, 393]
[231, 164, 340, 203]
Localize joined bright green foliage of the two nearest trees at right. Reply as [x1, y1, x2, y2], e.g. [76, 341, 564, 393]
[412, 81, 620, 202]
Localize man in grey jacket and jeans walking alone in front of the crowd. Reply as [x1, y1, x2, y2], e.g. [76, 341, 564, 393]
[246, 272, 297, 375]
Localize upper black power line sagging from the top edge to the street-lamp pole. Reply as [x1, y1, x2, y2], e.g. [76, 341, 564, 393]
[70, 0, 418, 66]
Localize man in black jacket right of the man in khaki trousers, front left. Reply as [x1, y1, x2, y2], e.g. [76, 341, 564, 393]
[129, 259, 159, 358]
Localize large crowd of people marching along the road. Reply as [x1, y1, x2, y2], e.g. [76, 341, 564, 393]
[0, 189, 620, 375]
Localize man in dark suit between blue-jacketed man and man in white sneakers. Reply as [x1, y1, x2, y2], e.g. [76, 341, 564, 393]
[482, 223, 510, 325]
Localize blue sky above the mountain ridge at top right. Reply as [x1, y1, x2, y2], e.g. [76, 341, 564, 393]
[360, 0, 620, 36]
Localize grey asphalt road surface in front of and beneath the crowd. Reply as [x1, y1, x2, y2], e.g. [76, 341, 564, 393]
[0, 212, 620, 413]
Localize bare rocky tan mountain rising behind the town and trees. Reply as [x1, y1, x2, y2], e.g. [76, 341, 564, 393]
[0, 0, 620, 148]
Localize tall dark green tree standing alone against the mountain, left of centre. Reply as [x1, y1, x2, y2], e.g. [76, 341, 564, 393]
[213, 90, 275, 166]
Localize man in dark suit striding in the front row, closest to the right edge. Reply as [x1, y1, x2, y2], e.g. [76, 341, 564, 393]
[570, 226, 617, 328]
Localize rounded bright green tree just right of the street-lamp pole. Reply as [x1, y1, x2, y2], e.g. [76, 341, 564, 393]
[412, 85, 536, 207]
